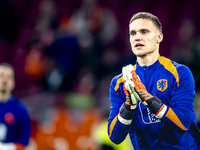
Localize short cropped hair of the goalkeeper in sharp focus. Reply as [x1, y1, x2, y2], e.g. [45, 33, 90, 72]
[129, 12, 162, 33]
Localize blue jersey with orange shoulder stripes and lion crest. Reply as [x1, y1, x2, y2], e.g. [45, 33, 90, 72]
[108, 56, 200, 150]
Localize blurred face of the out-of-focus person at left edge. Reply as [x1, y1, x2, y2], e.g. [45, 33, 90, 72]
[0, 66, 15, 95]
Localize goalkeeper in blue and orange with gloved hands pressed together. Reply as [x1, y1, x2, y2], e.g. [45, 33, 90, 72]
[108, 12, 200, 150]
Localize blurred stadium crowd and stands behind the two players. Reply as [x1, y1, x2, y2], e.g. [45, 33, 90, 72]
[0, 0, 200, 150]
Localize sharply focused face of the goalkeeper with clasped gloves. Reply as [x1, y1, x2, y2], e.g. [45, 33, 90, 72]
[129, 18, 163, 57]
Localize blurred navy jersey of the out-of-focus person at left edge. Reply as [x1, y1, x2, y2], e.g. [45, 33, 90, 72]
[0, 96, 31, 146]
